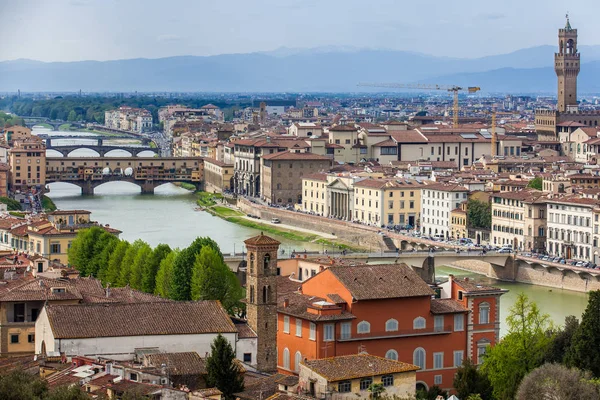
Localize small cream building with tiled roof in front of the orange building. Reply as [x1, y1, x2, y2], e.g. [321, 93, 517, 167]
[299, 353, 419, 400]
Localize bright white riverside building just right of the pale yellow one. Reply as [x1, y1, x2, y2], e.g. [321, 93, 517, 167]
[421, 183, 469, 239]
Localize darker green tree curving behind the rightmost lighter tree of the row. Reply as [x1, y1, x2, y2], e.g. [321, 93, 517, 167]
[171, 237, 223, 300]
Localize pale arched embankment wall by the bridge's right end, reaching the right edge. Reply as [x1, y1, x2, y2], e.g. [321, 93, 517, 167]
[451, 260, 600, 292]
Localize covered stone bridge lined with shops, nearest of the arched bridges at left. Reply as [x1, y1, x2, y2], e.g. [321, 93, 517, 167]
[46, 157, 204, 195]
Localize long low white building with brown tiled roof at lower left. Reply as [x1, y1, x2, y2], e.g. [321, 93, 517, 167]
[35, 301, 244, 361]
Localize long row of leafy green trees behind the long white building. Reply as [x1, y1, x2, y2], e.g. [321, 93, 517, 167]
[69, 233, 244, 315]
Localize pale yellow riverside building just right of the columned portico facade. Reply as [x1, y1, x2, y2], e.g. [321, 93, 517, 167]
[354, 178, 426, 227]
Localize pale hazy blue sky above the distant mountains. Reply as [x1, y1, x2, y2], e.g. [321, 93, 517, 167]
[0, 0, 600, 61]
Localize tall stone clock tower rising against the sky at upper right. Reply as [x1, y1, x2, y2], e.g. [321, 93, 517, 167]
[554, 14, 580, 113]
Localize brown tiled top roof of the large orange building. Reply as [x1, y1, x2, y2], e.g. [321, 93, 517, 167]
[326, 264, 433, 301]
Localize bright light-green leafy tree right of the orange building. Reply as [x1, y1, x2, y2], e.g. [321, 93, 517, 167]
[481, 293, 552, 400]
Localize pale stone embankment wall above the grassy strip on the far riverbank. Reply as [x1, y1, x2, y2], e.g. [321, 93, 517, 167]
[237, 199, 386, 251]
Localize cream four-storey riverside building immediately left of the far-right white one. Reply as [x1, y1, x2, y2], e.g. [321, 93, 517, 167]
[491, 189, 547, 251]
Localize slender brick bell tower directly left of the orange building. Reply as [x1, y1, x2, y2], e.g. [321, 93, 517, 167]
[244, 232, 280, 372]
